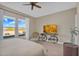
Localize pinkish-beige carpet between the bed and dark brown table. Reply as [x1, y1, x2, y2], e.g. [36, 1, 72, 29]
[34, 42, 63, 56]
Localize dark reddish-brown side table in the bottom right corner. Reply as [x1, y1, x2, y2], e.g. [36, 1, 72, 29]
[63, 43, 78, 56]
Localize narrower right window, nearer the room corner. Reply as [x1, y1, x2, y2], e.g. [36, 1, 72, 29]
[18, 19, 25, 36]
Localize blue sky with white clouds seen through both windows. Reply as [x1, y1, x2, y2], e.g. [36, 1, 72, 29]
[3, 17, 25, 27]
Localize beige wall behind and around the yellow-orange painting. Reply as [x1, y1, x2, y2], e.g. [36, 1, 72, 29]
[36, 8, 76, 42]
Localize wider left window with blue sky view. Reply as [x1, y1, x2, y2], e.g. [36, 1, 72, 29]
[3, 16, 15, 37]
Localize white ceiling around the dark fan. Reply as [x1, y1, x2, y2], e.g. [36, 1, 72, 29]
[0, 2, 76, 17]
